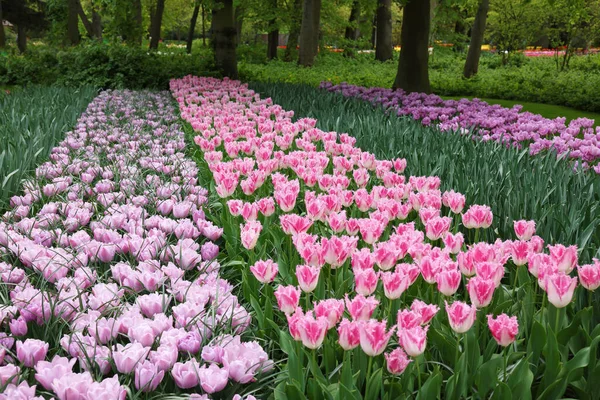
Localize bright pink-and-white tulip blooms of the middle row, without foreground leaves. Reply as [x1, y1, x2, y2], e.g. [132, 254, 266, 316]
[171, 76, 600, 396]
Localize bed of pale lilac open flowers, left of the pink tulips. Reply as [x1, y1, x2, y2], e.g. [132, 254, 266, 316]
[0, 91, 272, 400]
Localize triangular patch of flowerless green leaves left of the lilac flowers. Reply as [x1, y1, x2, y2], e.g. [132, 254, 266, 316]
[0, 86, 97, 208]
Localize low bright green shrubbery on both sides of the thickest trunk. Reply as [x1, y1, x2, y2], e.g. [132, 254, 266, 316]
[240, 49, 600, 111]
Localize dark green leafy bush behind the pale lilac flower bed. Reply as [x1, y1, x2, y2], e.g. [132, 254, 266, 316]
[0, 43, 214, 89]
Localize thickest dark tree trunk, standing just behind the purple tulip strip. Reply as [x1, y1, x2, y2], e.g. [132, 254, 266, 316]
[393, 0, 431, 93]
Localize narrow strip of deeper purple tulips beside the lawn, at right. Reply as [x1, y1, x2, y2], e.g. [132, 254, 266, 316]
[321, 82, 600, 174]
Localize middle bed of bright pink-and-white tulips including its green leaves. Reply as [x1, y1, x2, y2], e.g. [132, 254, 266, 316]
[171, 77, 600, 399]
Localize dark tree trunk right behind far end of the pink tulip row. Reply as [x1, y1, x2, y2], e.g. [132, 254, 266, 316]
[213, 0, 238, 79]
